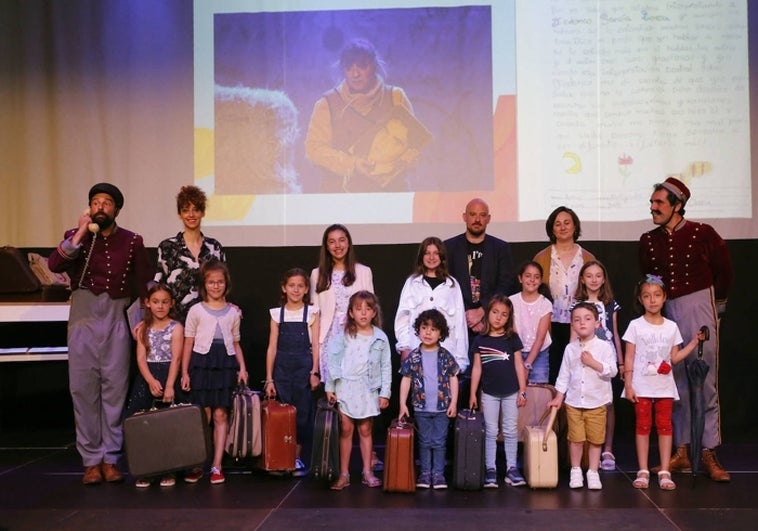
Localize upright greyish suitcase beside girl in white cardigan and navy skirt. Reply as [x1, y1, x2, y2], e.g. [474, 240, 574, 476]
[225, 385, 263, 459]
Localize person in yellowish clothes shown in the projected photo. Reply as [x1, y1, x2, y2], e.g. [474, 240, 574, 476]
[305, 39, 432, 192]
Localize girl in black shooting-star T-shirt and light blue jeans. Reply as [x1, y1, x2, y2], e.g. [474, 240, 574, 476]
[469, 294, 526, 489]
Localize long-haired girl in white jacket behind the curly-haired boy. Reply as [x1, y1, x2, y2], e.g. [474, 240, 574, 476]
[395, 236, 469, 372]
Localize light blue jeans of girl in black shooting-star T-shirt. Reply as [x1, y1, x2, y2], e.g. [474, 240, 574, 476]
[482, 393, 518, 469]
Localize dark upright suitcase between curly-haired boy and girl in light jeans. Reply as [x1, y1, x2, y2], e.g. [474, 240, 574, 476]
[453, 409, 484, 490]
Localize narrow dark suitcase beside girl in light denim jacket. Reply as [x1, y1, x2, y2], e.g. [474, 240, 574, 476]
[311, 399, 340, 481]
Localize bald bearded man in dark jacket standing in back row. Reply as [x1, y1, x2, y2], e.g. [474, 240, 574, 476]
[445, 198, 514, 376]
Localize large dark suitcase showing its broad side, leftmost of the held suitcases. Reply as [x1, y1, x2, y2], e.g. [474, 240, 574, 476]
[124, 404, 211, 478]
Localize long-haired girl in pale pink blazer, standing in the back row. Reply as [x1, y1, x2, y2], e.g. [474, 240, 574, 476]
[311, 224, 374, 381]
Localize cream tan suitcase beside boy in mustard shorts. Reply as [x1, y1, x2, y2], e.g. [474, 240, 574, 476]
[523, 407, 558, 489]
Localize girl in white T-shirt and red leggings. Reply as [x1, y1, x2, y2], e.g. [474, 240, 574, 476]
[622, 275, 703, 490]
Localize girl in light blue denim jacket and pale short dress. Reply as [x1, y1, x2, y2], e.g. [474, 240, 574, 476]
[325, 290, 392, 490]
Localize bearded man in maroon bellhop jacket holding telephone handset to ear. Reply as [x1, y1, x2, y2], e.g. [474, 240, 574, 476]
[48, 183, 153, 485]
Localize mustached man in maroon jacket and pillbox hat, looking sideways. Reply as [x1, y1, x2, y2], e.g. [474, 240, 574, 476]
[639, 177, 733, 482]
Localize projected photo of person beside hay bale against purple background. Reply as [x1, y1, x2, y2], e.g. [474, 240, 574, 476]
[209, 5, 492, 200]
